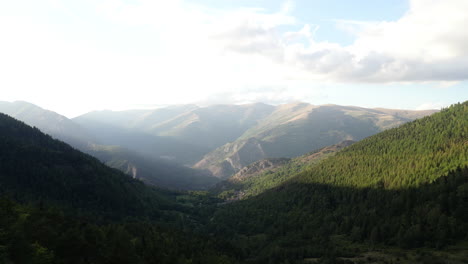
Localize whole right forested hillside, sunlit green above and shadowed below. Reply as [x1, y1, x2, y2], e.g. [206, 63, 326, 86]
[208, 102, 468, 263]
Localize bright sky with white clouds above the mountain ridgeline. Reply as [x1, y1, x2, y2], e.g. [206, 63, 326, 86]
[0, 0, 468, 117]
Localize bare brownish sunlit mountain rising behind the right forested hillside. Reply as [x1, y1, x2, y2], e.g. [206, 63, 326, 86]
[194, 103, 434, 178]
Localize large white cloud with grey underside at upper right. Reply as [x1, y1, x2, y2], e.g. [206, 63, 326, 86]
[217, 0, 468, 82]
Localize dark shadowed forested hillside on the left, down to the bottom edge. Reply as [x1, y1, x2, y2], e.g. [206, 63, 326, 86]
[0, 114, 235, 264]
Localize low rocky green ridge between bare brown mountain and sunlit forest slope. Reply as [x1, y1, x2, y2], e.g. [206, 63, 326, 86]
[210, 140, 354, 200]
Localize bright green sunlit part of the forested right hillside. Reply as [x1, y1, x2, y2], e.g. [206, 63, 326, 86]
[298, 102, 468, 188]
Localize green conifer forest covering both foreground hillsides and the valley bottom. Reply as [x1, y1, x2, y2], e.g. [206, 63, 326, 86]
[0, 102, 468, 264]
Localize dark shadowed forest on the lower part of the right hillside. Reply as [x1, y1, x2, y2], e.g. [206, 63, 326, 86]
[210, 167, 468, 263]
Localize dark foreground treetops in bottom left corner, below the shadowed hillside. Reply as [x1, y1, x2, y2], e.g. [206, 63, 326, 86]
[0, 198, 234, 264]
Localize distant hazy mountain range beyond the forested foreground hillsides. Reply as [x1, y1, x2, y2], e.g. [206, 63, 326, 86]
[0, 101, 435, 189]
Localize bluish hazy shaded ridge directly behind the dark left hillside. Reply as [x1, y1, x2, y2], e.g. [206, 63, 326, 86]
[87, 145, 219, 190]
